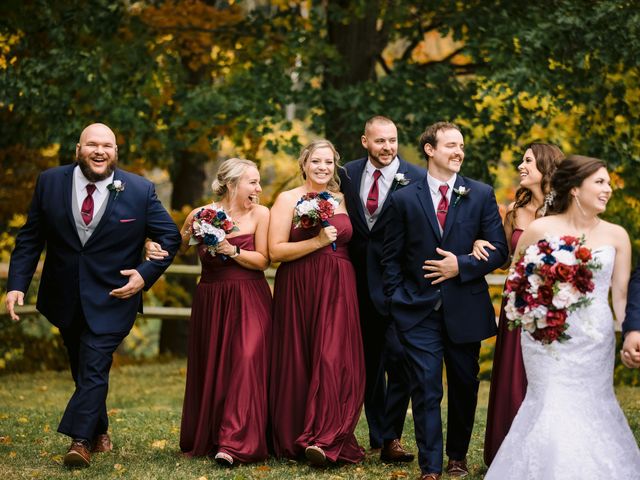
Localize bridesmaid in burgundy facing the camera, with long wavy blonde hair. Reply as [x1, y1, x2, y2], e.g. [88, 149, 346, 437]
[269, 140, 365, 466]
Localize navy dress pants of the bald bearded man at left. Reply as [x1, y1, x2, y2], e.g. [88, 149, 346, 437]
[58, 306, 128, 441]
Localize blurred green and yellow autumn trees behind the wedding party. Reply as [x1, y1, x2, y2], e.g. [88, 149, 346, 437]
[0, 0, 640, 364]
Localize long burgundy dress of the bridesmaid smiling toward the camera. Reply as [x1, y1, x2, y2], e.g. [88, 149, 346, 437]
[269, 214, 365, 463]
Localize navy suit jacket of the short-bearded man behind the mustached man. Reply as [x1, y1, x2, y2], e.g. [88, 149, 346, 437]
[340, 157, 427, 315]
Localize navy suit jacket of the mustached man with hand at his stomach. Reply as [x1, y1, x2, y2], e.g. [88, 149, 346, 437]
[382, 175, 508, 343]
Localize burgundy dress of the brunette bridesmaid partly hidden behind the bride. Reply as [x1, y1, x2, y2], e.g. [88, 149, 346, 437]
[484, 229, 527, 466]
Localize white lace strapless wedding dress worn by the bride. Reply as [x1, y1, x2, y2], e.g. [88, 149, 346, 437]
[485, 246, 640, 480]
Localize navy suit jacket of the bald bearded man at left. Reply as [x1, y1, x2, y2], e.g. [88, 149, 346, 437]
[7, 163, 180, 334]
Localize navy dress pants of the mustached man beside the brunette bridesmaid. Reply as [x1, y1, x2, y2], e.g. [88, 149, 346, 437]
[399, 308, 480, 473]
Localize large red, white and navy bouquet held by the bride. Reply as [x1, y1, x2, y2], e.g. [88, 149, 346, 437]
[504, 236, 601, 344]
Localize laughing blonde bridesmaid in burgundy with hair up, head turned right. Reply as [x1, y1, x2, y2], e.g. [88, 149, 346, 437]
[146, 158, 272, 466]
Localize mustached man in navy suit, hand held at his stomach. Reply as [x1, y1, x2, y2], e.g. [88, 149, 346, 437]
[382, 122, 508, 480]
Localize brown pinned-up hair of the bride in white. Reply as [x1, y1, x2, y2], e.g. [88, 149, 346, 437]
[551, 155, 607, 213]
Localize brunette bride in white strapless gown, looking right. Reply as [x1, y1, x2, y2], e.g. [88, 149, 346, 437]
[485, 156, 640, 480]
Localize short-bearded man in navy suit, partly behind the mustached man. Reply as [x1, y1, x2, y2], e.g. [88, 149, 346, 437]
[340, 116, 426, 462]
